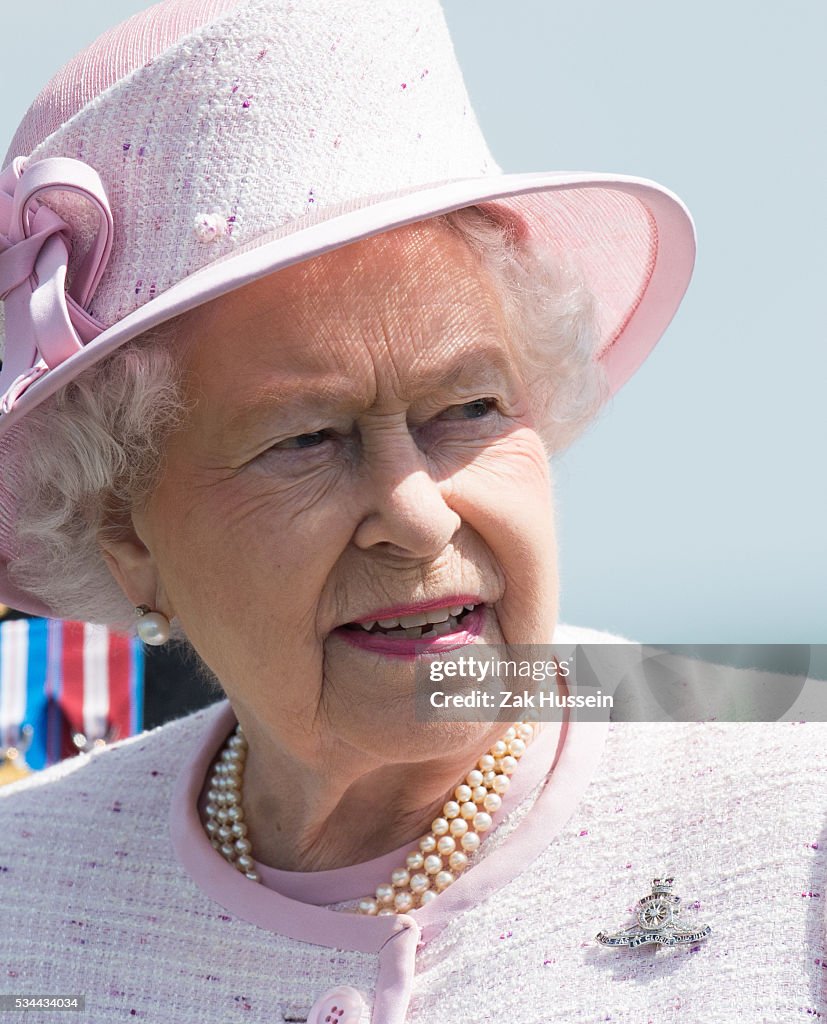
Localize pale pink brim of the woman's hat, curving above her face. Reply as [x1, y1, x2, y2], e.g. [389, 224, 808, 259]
[0, 172, 695, 437]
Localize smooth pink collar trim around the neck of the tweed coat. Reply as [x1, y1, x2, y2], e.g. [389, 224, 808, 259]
[170, 700, 608, 953]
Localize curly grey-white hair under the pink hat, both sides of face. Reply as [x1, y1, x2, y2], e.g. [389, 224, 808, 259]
[6, 207, 608, 635]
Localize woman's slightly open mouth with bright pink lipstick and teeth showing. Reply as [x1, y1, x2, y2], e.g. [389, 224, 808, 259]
[334, 598, 487, 655]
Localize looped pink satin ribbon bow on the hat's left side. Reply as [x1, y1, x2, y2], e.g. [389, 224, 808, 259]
[0, 157, 114, 414]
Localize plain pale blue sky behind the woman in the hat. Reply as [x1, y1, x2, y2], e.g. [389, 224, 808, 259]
[0, 0, 827, 643]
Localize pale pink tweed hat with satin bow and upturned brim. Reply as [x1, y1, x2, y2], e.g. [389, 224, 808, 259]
[0, 0, 695, 612]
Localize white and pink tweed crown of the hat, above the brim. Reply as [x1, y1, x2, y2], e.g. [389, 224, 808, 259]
[3, 0, 496, 328]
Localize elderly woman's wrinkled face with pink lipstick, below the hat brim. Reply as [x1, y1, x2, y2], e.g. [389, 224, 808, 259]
[113, 223, 557, 757]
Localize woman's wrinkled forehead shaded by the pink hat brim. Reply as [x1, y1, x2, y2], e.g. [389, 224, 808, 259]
[177, 221, 508, 415]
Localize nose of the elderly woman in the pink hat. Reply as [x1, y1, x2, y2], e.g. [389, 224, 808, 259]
[353, 430, 462, 559]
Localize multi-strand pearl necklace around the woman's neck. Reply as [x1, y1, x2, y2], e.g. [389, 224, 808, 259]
[206, 722, 534, 916]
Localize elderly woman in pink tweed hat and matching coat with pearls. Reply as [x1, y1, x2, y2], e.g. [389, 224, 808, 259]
[0, 0, 824, 1024]
